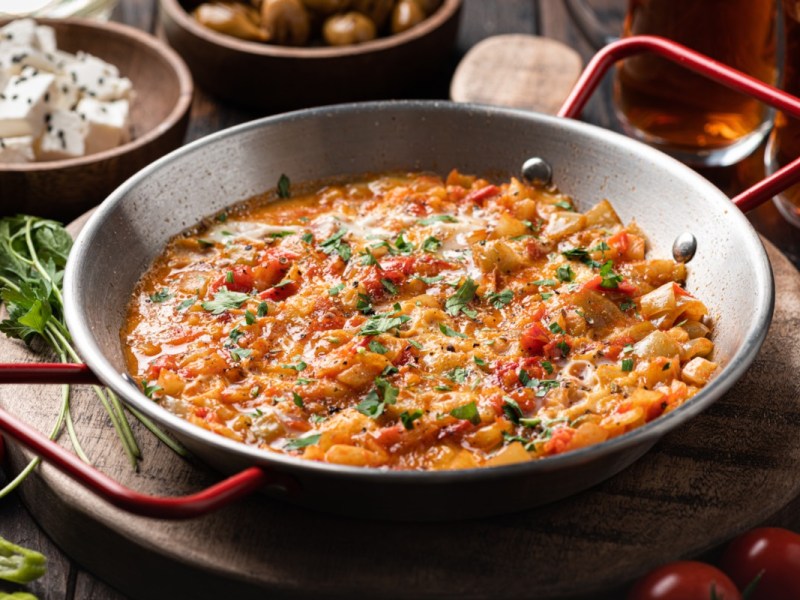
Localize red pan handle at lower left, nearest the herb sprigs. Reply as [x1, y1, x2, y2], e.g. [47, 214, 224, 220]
[0, 363, 297, 519]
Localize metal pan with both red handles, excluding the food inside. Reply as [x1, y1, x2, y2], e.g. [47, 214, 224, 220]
[0, 37, 800, 519]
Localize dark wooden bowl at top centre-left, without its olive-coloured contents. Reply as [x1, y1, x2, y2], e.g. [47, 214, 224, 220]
[160, 0, 462, 113]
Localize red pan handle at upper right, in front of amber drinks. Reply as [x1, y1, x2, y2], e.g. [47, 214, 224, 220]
[558, 35, 800, 212]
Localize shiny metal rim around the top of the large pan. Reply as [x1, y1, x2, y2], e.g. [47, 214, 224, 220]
[64, 100, 775, 485]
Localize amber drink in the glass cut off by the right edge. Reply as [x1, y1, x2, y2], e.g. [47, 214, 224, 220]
[767, 0, 800, 227]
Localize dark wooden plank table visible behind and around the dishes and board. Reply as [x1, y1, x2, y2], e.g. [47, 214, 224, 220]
[0, 0, 800, 600]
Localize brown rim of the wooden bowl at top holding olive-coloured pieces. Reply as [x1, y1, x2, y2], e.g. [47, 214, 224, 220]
[159, 0, 463, 59]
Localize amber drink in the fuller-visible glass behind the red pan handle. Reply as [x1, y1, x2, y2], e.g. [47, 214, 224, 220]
[615, 0, 777, 165]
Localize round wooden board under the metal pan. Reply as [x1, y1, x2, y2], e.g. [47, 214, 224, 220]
[0, 227, 800, 600]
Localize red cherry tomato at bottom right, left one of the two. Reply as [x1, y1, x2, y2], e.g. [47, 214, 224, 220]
[628, 561, 742, 600]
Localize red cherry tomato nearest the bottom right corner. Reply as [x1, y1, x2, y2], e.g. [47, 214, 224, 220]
[720, 527, 800, 600]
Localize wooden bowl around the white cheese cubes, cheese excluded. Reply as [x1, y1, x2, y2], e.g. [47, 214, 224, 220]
[0, 19, 193, 221]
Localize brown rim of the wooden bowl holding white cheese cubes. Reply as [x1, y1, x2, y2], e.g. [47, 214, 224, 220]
[0, 18, 194, 174]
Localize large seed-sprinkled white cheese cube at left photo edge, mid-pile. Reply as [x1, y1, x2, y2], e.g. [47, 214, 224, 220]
[0, 70, 55, 137]
